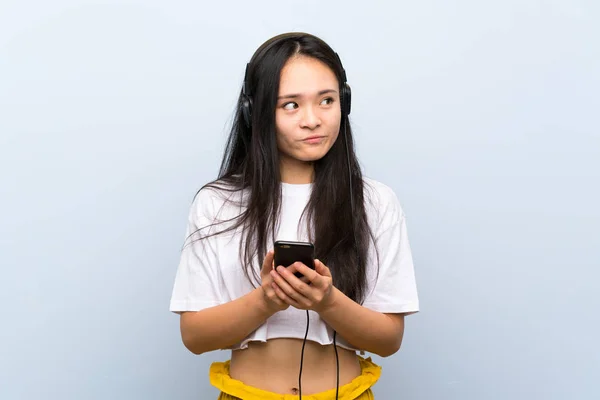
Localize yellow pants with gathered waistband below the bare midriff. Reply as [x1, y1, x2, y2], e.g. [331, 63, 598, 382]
[209, 356, 381, 400]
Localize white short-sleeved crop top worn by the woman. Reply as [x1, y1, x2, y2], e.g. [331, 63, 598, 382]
[170, 178, 419, 351]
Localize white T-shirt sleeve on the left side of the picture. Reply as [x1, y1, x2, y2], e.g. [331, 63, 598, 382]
[170, 189, 222, 312]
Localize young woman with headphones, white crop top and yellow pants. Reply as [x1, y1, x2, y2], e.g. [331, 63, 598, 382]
[170, 33, 419, 400]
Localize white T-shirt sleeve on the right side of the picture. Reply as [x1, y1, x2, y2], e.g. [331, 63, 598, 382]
[363, 187, 419, 314]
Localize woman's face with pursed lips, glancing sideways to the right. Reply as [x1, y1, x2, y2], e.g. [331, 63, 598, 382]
[275, 56, 341, 163]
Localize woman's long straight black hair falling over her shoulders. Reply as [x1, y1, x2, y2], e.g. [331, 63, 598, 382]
[192, 32, 372, 303]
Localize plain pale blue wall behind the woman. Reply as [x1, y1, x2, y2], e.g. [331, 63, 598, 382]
[0, 0, 600, 400]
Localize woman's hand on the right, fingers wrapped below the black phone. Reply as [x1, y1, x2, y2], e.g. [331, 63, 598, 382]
[270, 260, 333, 312]
